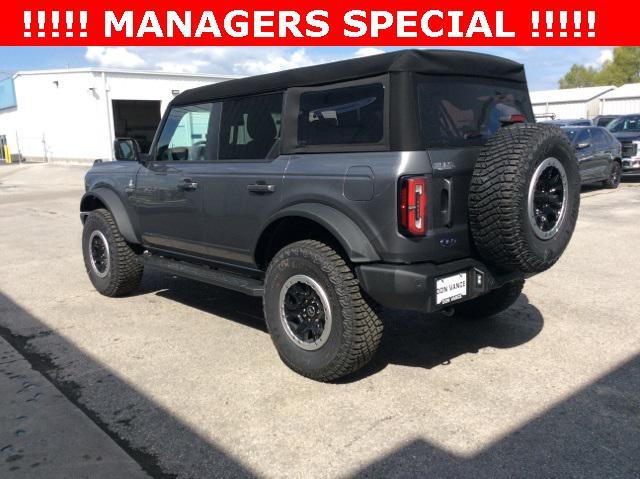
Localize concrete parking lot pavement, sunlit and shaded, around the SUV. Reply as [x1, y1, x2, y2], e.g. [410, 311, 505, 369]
[0, 164, 640, 478]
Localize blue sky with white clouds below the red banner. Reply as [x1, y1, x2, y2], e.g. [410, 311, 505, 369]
[0, 47, 613, 90]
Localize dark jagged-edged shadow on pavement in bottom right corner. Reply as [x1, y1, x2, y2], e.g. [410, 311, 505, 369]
[355, 355, 640, 479]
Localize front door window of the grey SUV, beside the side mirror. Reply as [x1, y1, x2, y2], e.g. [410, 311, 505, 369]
[156, 103, 215, 161]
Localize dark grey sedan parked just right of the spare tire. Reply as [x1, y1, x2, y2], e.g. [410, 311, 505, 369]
[562, 126, 622, 188]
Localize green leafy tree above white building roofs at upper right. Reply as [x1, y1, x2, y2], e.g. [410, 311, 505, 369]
[559, 47, 640, 88]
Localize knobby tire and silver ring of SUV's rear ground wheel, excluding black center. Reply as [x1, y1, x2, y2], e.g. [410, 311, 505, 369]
[264, 240, 383, 381]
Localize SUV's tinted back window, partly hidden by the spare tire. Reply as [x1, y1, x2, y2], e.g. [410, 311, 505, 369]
[418, 77, 533, 146]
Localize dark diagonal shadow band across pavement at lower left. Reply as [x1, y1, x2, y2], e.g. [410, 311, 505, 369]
[0, 292, 256, 478]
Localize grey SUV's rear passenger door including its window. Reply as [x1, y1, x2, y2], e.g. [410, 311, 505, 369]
[198, 92, 288, 268]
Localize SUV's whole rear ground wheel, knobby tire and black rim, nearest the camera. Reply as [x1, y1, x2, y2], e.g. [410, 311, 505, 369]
[264, 240, 383, 381]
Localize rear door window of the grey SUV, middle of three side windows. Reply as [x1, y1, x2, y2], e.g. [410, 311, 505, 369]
[218, 93, 282, 160]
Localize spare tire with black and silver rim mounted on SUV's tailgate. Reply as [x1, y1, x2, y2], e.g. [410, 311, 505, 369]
[469, 123, 580, 273]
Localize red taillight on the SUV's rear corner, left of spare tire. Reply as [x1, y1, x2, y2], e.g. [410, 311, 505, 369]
[398, 177, 427, 236]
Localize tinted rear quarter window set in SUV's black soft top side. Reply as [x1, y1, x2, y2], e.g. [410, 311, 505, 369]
[298, 83, 384, 146]
